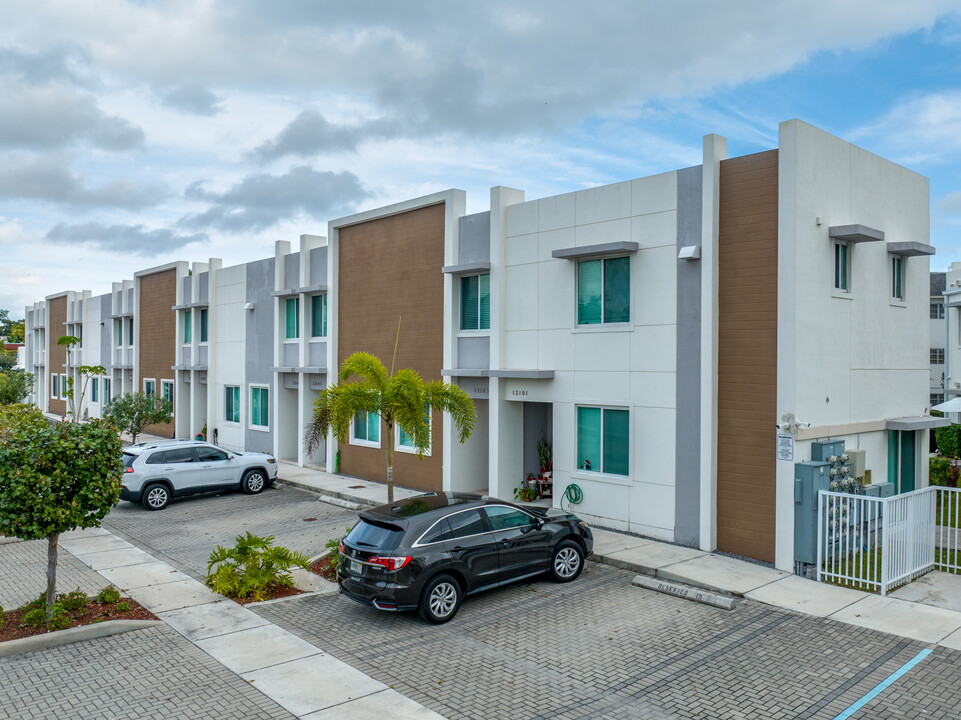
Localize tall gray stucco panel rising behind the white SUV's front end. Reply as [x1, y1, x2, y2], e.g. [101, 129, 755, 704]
[241, 255, 274, 453]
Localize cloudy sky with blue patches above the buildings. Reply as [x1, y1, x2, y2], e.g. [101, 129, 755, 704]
[0, 0, 961, 317]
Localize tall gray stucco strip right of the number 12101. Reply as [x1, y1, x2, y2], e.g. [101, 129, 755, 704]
[674, 166, 702, 547]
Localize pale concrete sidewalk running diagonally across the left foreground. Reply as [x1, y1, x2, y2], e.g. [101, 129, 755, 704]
[60, 528, 443, 720]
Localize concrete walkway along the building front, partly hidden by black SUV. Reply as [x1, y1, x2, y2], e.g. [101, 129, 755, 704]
[278, 463, 961, 650]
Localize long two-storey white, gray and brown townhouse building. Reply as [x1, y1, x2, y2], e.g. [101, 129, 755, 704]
[27, 120, 940, 570]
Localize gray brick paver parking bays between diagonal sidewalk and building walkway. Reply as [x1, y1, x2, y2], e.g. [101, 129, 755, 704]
[11, 488, 961, 720]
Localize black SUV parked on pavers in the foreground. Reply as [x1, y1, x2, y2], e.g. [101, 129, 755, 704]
[337, 493, 594, 623]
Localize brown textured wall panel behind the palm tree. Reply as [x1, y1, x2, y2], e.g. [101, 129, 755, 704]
[337, 203, 445, 491]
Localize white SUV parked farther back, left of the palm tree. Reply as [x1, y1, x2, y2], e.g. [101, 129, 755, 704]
[120, 440, 277, 510]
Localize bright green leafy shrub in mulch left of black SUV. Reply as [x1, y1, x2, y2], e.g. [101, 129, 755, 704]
[206, 531, 310, 600]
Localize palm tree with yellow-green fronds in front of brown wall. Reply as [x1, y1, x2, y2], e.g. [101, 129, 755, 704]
[304, 352, 474, 503]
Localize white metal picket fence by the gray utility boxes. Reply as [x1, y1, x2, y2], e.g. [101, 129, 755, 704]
[817, 487, 948, 595]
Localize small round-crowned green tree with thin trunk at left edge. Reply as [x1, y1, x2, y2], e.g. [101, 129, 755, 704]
[0, 405, 123, 617]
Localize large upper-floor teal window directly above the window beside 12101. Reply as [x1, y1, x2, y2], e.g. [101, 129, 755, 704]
[577, 257, 631, 325]
